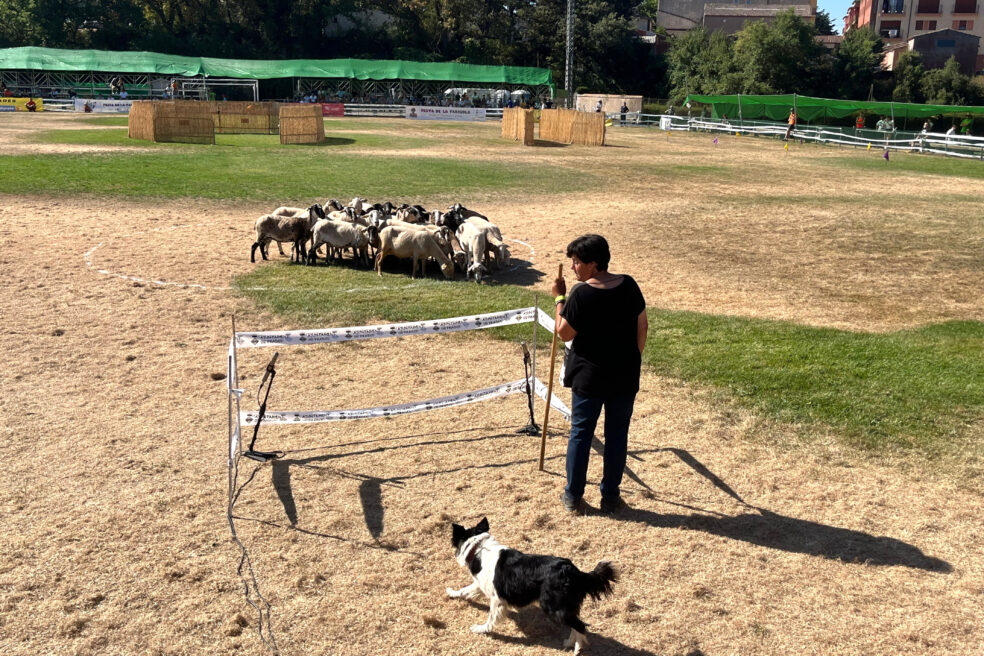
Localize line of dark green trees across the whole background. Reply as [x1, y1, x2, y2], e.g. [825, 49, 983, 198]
[0, 0, 984, 104]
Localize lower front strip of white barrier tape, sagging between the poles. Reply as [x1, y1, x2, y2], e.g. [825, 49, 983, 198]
[240, 378, 526, 426]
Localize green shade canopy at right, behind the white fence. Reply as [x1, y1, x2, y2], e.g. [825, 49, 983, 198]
[687, 94, 984, 121]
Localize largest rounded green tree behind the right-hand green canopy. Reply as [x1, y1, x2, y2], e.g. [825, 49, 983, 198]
[734, 9, 829, 94]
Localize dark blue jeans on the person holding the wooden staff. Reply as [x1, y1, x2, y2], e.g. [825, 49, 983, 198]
[564, 392, 635, 499]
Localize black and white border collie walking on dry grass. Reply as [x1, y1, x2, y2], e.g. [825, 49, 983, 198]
[447, 517, 618, 654]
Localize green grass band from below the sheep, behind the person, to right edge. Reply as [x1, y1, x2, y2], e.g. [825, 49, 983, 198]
[235, 260, 984, 455]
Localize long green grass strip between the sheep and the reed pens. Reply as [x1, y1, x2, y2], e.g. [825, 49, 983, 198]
[0, 146, 596, 203]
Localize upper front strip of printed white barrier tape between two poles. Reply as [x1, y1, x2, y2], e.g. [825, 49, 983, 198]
[236, 307, 534, 348]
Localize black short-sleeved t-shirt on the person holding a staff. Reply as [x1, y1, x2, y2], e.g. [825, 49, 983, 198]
[561, 276, 646, 398]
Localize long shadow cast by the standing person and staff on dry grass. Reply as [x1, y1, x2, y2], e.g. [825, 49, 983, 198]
[594, 439, 953, 573]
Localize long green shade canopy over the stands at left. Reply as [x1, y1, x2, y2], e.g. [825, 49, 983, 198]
[0, 46, 553, 87]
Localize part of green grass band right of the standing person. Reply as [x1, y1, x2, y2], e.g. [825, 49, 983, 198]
[645, 311, 984, 453]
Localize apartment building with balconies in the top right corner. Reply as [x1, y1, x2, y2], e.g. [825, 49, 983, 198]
[844, 0, 984, 74]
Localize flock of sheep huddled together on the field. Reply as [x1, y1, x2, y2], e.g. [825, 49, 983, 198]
[250, 197, 509, 282]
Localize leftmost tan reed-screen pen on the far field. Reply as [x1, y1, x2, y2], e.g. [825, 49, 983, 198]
[128, 100, 215, 144]
